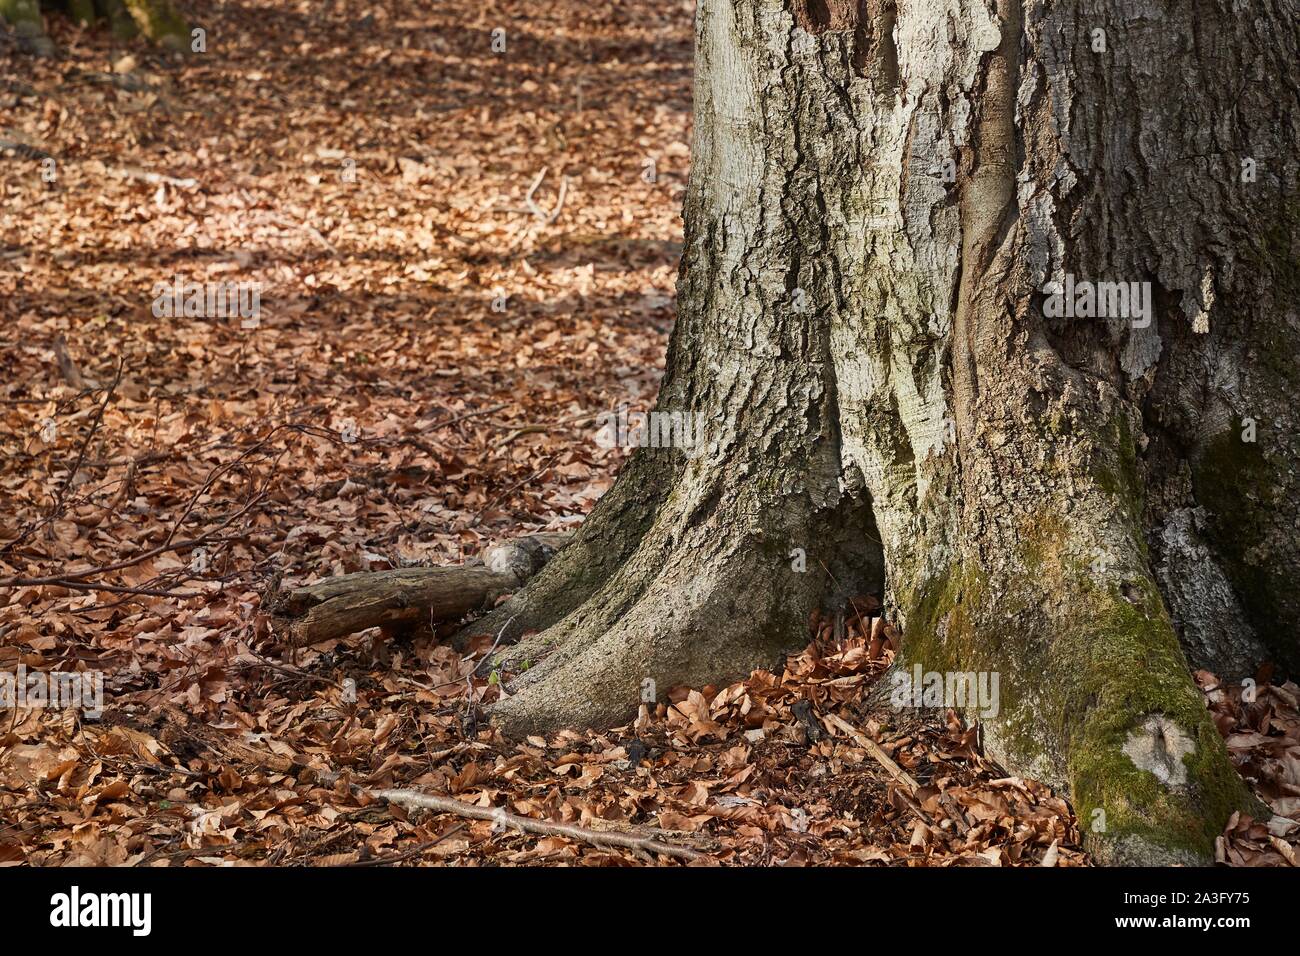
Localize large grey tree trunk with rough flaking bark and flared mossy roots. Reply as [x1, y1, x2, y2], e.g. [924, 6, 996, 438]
[462, 0, 1300, 862]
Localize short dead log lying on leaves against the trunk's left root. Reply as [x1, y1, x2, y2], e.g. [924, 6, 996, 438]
[268, 533, 573, 646]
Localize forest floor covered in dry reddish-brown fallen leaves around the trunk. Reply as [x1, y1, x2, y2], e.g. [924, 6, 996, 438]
[0, 0, 1300, 866]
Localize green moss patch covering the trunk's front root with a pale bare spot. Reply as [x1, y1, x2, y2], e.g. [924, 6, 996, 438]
[902, 515, 1260, 864]
